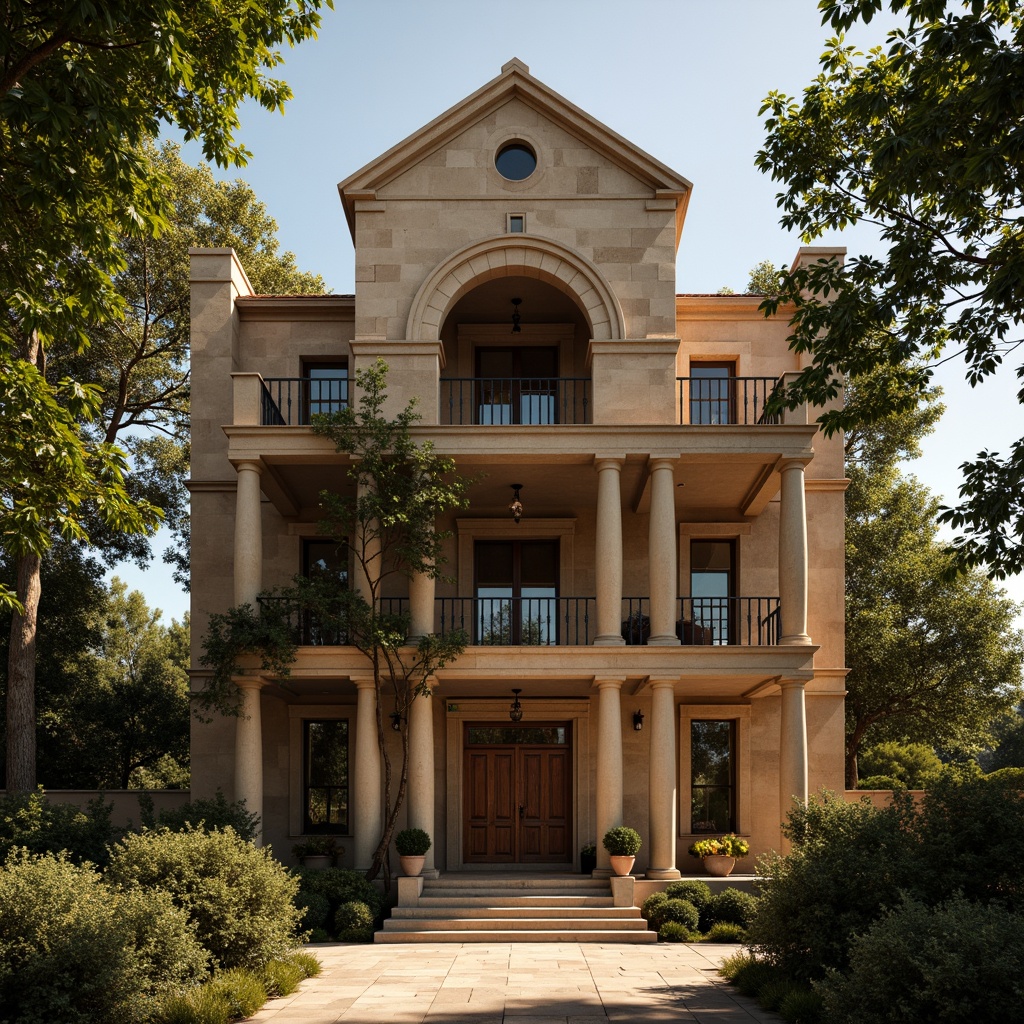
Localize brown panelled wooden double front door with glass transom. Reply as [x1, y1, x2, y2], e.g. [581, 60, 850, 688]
[463, 723, 572, 864]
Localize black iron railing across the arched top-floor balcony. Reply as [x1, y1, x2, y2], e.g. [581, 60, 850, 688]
[440, 377, 590, 426]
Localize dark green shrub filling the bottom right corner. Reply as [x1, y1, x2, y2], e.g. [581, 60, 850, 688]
[820, 897, 1024, 1024]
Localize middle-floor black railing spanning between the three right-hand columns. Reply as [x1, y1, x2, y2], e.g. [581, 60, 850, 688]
[622, 597, 780, 647]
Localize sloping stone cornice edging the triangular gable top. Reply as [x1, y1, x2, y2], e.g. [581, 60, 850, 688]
[338, 59, 691, 233]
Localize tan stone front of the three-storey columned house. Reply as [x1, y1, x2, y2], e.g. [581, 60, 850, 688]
[191, 60, 846, 879]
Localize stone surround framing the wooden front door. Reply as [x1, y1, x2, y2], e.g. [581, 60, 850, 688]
[444, 696, 594, 871]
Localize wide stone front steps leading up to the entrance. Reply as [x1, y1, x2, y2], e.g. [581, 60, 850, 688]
[374, 874, 657, 942]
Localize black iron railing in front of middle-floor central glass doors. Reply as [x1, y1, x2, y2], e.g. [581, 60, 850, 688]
[437, 597, 597, 647]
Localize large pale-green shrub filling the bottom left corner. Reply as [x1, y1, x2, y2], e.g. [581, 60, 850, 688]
[0, 853, 207, 1024]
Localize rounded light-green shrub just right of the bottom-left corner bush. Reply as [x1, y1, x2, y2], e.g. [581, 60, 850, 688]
[108, 827, 299, 969]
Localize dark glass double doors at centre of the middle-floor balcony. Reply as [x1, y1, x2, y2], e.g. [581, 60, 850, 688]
[474, 541, 558, 647]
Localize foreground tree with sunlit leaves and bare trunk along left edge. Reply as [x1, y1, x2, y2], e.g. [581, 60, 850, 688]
[0, 0, 330, 791]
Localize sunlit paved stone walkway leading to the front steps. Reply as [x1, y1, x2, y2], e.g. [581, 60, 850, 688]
[252, 942, 781, 1024]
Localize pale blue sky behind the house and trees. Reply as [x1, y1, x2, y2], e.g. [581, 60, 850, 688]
[117, 0, 1024, 618]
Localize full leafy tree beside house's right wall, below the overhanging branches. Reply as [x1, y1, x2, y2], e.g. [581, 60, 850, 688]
[846, 467, 1024, 788]
